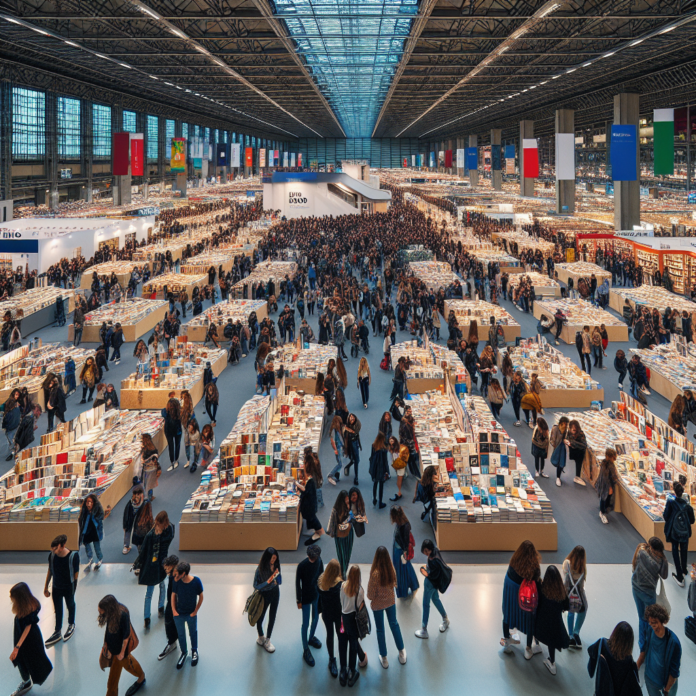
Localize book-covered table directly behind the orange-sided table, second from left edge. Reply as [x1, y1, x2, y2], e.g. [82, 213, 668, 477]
[80, 298, 169, 343]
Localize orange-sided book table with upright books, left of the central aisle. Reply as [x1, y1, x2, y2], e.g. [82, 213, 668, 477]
[121, 336, 227, 409]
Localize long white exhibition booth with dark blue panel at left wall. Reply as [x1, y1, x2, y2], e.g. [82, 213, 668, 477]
[0, 215, 155, 273]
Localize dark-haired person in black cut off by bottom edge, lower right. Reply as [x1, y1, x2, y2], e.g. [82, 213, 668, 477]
[587, 621, 643, 696]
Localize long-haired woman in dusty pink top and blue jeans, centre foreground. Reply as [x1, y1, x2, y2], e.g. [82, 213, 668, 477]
[367, 546, 406, 669]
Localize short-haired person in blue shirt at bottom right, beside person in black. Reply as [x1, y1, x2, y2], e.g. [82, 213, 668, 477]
[637, 604, 682, 696]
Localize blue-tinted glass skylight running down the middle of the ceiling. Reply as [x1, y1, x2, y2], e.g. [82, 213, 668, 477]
[273, 0, 418, 138]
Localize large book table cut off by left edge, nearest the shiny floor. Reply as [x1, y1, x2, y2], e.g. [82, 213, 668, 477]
[0, 406, 167, 551]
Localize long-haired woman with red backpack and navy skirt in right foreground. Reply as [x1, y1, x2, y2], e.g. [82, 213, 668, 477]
[500, 541, 541, 660]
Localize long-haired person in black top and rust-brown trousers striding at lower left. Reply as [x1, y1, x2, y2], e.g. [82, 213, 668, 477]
[97, 595, 145, 696]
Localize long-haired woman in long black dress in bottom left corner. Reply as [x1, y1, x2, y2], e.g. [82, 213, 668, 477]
[10, 582, 53, 696]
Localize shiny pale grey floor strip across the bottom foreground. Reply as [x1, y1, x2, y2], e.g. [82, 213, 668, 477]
[0, 554, 696, 696]
